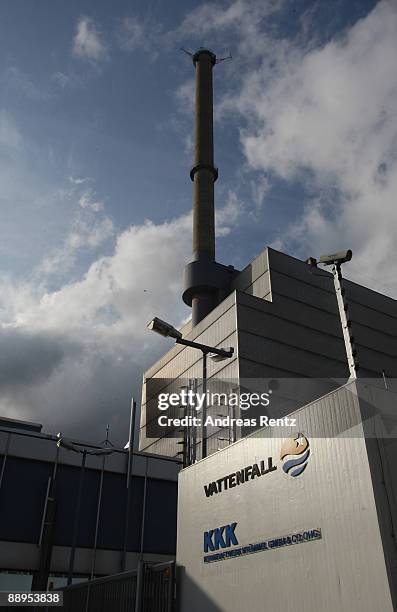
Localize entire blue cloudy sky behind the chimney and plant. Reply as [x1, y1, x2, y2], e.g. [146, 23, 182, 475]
[0, 0, 397, 443]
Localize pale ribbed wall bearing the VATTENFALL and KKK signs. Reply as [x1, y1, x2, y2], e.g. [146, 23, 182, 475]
[177, 383, 396, 612]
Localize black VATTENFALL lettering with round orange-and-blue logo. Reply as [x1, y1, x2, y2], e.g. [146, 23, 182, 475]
[204, 433, 310, 497]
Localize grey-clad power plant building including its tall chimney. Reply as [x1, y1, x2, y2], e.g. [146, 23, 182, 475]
[140, 49, 397, 457]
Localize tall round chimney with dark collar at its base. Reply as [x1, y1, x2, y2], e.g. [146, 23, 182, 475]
[182, 48, 235, 327]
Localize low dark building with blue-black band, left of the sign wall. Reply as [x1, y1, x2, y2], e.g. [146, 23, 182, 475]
[0, 418, 180, 590]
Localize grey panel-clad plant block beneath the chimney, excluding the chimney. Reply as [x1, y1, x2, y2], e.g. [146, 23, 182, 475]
[140, 248, 397, 457]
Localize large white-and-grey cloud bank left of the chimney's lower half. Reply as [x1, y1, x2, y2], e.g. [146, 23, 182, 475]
[0, 195, 240, 441]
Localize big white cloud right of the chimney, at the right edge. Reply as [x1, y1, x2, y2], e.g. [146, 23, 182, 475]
[225, 0, 397, 295]
